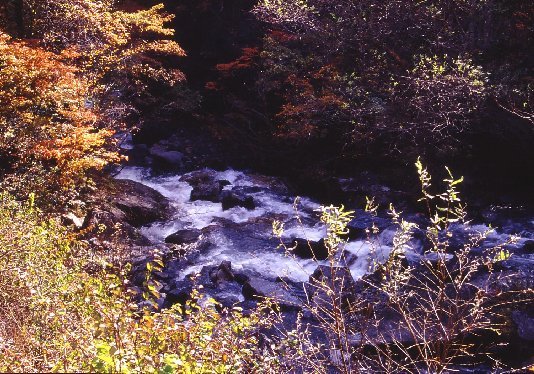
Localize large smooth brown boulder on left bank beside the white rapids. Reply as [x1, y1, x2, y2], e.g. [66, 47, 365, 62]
[112, 179, 172, 227]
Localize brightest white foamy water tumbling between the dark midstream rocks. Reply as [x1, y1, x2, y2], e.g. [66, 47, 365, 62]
[116, 167, 389, 281]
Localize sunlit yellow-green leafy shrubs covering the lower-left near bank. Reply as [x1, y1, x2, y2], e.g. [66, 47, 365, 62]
[0, 194, 284, 373]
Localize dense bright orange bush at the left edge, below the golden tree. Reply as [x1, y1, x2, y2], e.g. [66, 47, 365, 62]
[0, 34, 118, 196]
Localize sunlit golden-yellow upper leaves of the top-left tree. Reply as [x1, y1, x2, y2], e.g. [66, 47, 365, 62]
[30, 0, 185, 80]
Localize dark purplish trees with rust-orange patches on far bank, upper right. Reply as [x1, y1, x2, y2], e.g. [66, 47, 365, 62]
[253, 0, 534, 158]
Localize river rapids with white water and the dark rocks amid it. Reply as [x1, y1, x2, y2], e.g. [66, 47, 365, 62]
[116, 159, 534, 305]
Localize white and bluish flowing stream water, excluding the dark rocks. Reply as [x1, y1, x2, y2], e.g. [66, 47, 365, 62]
[116, 162, 534, 288]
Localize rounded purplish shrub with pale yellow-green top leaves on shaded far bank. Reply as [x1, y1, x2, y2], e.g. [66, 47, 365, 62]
[392, 56, 487, 153]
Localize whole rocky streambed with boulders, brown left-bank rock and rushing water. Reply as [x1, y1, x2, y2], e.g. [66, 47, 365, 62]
[86, 131, 534, 368]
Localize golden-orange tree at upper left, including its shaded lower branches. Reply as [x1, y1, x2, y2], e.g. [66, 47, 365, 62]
[29, 0, 191, 126]
